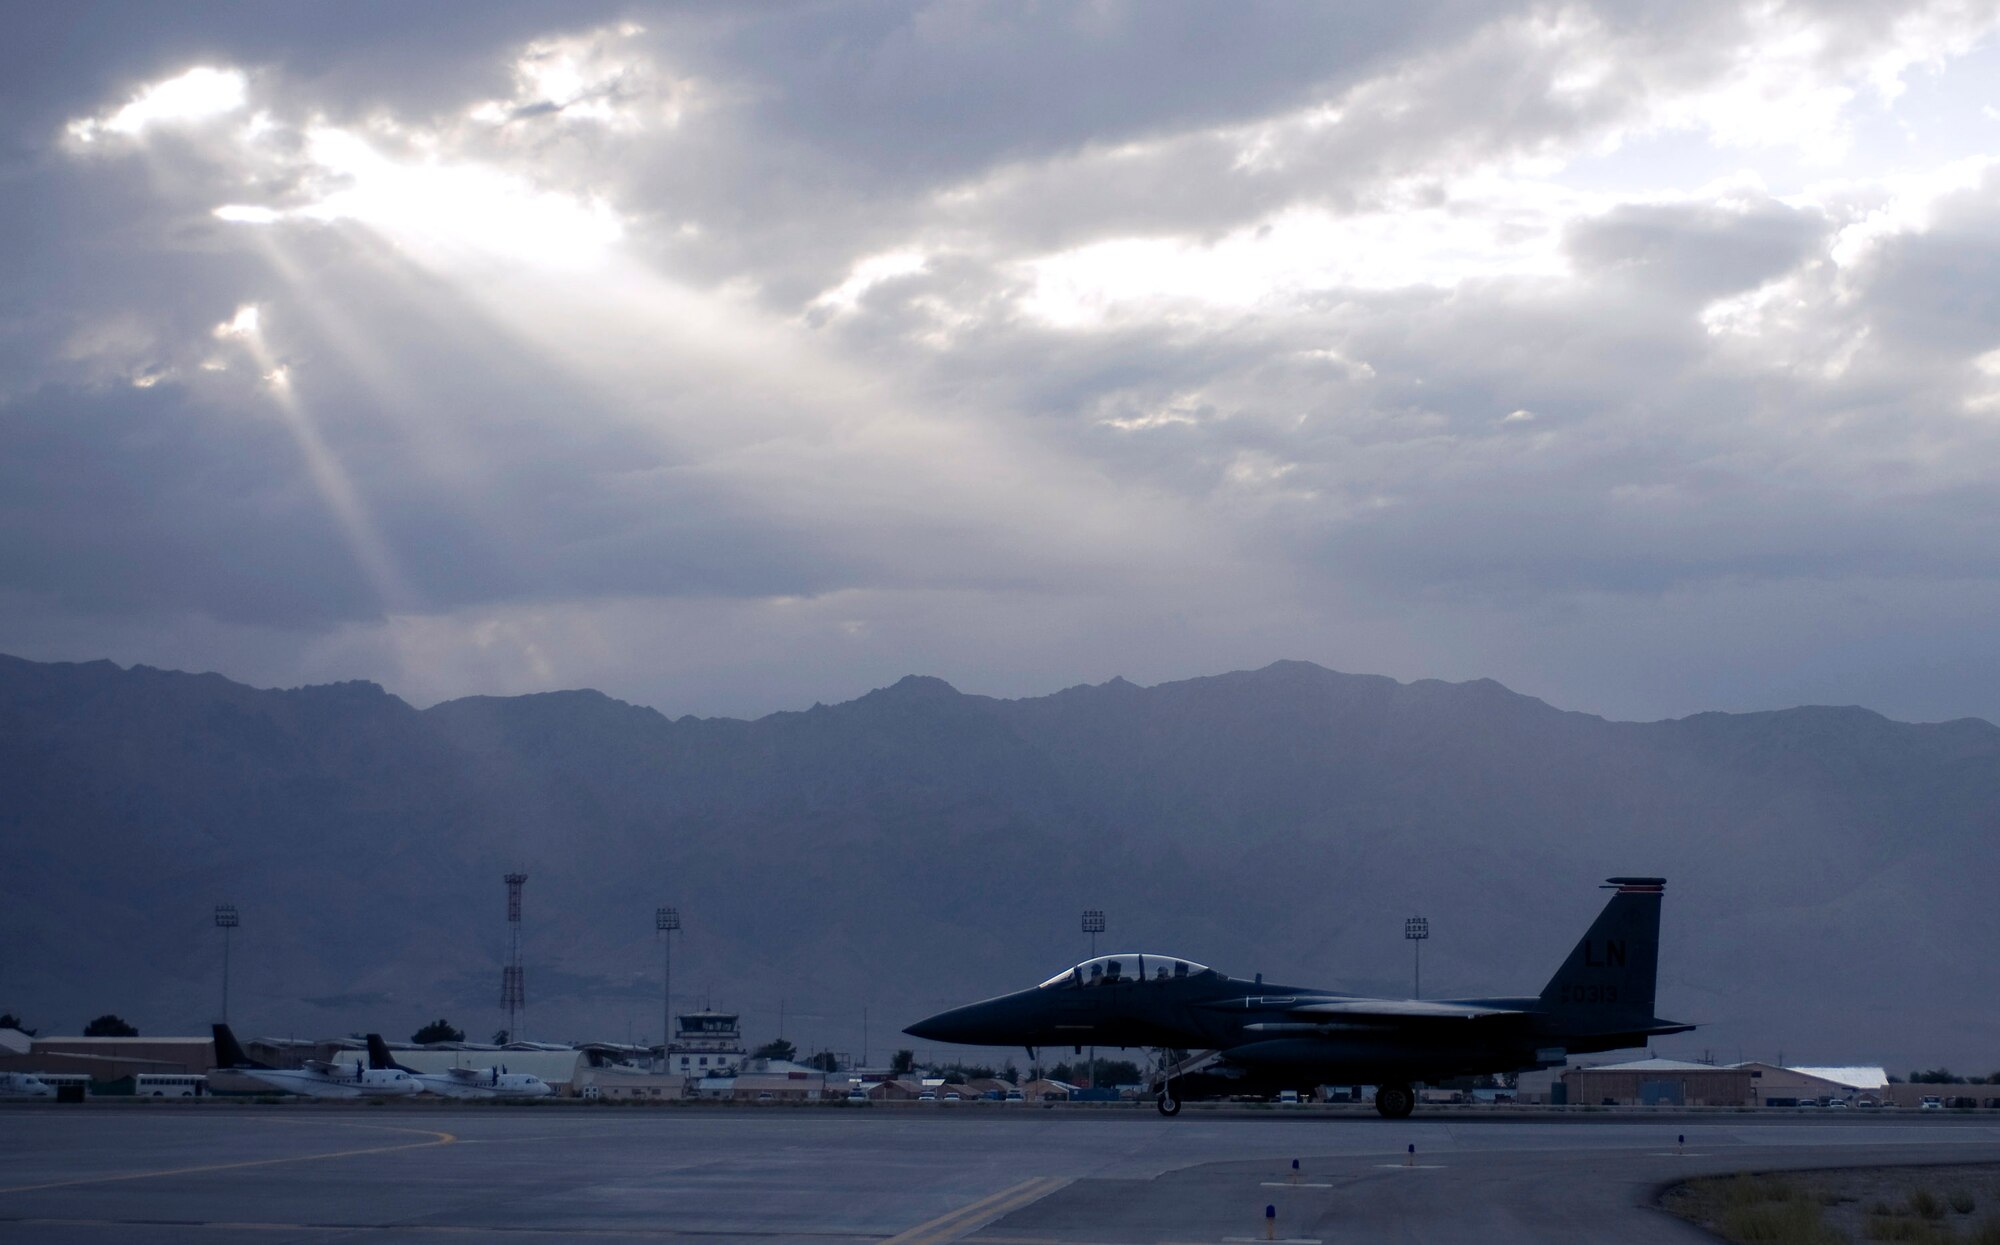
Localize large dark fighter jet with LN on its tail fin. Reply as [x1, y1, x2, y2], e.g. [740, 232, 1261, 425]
[904, 877, 1694, 1119]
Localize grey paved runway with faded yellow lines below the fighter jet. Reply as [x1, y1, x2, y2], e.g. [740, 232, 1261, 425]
[0, 1105, 2000, 1245]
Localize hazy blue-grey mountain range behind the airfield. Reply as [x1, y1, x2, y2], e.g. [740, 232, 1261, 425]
[0, 659, 2000, 1073]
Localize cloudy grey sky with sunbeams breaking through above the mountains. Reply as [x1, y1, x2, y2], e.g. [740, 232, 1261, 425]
[11, 0, 2000, 721]
